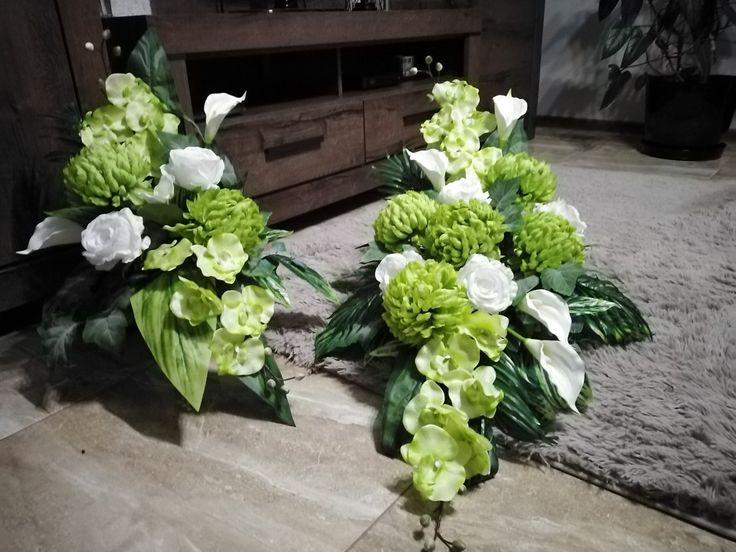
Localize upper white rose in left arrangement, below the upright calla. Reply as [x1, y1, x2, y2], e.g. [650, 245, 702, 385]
[162, 146, 225, 191]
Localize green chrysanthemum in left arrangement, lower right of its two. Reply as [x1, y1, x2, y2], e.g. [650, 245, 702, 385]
[183, 188, 265, 253]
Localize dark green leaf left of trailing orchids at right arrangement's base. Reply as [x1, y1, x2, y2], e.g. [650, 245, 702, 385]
[378, 351, 424, 456]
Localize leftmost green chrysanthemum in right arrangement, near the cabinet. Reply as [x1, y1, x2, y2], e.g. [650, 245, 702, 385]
[373, 191, 437, 251]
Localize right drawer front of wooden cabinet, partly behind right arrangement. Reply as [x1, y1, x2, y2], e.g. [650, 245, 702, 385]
[365, 90, 438, 161]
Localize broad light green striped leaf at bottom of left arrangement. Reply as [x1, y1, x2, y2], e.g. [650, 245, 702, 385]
[130, 274, 213, 411]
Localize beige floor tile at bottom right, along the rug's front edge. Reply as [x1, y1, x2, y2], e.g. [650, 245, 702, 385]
[350, 462, 736, 552]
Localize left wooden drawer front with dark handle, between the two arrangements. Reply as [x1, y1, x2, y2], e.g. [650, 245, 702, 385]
[217, 101, 365, 197]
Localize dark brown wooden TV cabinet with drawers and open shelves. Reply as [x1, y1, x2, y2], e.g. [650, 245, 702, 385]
[148, 9, 481, 222]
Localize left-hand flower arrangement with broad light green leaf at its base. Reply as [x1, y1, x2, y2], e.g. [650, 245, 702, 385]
[20, 33, 335, 424]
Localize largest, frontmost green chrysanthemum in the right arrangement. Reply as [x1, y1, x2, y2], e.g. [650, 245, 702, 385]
[383, 260, 472, 345]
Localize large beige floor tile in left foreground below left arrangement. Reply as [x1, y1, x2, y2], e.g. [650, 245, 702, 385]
[0, 362, 406, 552]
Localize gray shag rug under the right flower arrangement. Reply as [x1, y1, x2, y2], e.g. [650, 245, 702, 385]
[270, 166, 736, 539]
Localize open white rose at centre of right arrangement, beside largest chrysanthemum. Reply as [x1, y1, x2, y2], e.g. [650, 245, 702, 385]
[457, 255, 518, 314]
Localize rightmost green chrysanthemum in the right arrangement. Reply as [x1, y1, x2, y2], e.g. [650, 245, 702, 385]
[514, 212, 585, 272]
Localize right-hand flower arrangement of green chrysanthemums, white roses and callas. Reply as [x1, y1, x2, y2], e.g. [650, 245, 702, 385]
[316, 80, 651, 536]
